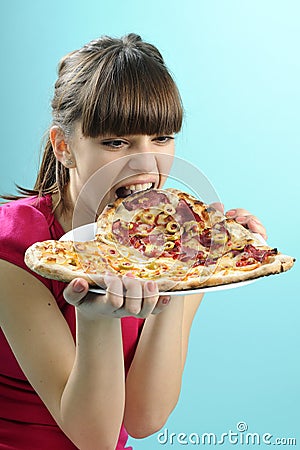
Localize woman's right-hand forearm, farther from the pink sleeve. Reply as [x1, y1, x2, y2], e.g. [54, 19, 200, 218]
[124, 298, 184, 437]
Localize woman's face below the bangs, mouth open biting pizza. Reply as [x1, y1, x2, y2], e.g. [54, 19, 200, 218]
[63, 124, 175, 222]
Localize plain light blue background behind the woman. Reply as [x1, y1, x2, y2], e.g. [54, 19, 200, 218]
[0, 0, 300, 450]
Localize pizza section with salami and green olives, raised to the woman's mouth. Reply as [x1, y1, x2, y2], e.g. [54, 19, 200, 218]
[96, 189, 294, 290]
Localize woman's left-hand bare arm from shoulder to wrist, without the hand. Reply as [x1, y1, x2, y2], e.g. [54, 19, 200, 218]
[0, 261, 125, 450]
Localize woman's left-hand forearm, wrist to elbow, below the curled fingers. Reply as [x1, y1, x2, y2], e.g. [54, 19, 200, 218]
[61, 313, 125, 450]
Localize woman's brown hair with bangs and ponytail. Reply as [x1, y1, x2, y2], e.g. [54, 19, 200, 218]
[3, 33, 183, 209]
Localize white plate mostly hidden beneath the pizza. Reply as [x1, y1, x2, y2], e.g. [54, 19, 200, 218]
[60, 223, 266, 297]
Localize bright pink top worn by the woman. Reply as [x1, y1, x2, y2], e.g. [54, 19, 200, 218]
[0, 195, 144, 450]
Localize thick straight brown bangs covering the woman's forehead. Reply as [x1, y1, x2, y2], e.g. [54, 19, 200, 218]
[81, 49, 183, 137]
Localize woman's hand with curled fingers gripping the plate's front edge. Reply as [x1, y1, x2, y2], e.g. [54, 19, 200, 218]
[64, 274, 170, 320]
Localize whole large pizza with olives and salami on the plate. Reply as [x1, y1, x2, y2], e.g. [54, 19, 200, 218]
[25, 189, 294, 291]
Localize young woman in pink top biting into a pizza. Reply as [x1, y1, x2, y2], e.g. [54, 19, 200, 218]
[0, 34, 265, 450]
